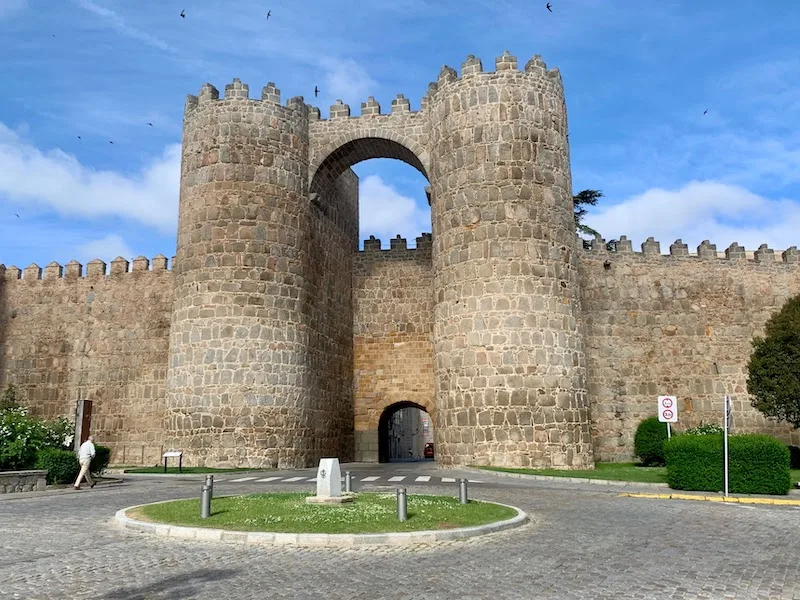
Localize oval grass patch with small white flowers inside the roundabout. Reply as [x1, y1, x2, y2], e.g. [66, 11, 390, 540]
[128, 492, 517, 533]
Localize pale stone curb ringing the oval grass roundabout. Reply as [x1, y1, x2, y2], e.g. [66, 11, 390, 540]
[109, 500, 530, 548]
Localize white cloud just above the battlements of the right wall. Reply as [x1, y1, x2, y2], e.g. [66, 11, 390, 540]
[585, 181, 800, 254]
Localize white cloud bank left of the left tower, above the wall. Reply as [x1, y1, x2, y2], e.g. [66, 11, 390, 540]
[0, 123, 181, 233]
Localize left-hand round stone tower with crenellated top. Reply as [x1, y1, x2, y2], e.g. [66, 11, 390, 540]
[166, 79, 352, 468]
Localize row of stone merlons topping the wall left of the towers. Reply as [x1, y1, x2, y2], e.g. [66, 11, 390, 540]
[0, 254, 175, 282]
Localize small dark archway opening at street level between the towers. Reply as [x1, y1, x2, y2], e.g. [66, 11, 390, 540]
[378, 402, 435, 463]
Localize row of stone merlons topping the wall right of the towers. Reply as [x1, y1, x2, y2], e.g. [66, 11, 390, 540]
[582, 235, 800, 264]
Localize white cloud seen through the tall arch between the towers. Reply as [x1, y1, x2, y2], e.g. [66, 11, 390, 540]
[359, 175, 431, 248]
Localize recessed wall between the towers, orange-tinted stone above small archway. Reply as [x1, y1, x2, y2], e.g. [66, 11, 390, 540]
[353, 235, 436, 462]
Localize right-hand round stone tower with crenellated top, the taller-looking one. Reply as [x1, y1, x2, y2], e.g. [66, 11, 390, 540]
[428, 52, 594, 468]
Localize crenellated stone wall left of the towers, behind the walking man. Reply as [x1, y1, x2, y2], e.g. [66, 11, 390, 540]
[0, 256, 172, 464]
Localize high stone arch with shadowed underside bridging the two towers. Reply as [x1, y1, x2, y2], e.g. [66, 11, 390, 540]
[308, 129, 431, 191]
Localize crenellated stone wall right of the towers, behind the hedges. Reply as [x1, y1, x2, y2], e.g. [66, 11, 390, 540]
[580, 238, 800, 461]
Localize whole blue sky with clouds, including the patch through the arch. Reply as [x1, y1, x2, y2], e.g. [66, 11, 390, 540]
[0, 0, 800, 267]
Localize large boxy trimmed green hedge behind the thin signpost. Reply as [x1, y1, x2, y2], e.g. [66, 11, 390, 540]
[664, 434, 792, 495]
